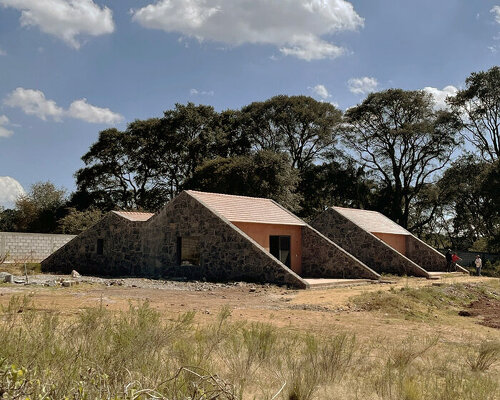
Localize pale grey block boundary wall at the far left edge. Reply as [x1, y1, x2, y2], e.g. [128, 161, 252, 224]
[0, 232, 75, 262]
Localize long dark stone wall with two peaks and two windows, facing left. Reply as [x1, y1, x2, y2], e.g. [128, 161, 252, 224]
[42, 192, 308, 288]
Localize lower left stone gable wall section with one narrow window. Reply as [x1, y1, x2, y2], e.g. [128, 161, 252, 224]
[42, 212, 145, 276]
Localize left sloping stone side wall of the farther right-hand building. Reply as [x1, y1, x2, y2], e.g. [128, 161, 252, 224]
[311, 208, 429, 277]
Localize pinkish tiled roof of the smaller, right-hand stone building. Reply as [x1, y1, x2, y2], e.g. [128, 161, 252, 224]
[332, 207, 411, 235]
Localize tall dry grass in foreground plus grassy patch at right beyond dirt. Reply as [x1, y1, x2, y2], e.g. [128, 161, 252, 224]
[0, 285, 500, 400]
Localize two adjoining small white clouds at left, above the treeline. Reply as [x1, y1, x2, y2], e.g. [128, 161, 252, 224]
[4, 87, 123, 124]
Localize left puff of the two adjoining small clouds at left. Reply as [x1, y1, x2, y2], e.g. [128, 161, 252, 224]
[4, 87, 64, 121]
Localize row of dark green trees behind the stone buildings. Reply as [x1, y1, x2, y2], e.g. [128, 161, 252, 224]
[0, 67, 500, 252]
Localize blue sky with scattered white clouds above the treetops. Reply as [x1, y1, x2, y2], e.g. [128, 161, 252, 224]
[0, 0, 500, 207]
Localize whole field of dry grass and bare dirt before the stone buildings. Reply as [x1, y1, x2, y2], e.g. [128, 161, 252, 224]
[0, 278, 500, 400]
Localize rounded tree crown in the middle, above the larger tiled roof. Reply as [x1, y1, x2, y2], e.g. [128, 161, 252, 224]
[241, 95, 342, 171]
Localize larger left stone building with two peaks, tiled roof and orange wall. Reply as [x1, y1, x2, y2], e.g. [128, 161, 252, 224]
[42, 190, 379, 288]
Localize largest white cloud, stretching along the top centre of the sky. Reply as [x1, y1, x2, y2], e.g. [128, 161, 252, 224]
[132, 0, 364, 61]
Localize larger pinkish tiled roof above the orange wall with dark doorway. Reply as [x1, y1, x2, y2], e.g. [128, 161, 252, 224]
[186, 190, 306, 226]
